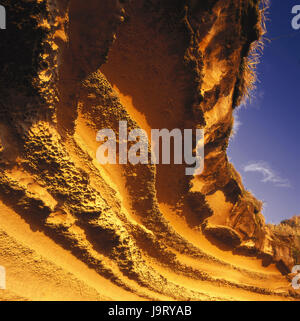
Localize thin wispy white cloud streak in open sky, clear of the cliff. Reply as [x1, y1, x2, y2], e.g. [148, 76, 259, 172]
[243, 161, 291, 188]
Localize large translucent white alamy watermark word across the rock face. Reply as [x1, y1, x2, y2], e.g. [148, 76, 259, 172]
[96, 121, 204, 175]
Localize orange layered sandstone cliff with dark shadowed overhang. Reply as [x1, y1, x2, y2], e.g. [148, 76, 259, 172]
[0, 0, 300, 300]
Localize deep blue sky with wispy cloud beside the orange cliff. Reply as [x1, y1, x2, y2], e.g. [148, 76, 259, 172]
[228, 0, 300, 223]
